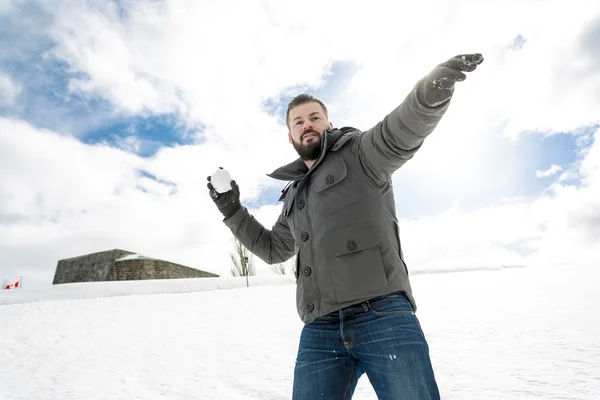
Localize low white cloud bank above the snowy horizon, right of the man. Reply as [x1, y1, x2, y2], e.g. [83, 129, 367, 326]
[401, 130, 600, 269]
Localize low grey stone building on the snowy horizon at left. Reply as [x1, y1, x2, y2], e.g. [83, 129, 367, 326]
[52, 249, 219, 285]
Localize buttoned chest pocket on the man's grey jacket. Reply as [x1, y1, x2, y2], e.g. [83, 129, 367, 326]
[311, 157, 362, 214]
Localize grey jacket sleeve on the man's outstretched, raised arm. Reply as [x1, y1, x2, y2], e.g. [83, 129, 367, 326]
[355, 80, 450, 185]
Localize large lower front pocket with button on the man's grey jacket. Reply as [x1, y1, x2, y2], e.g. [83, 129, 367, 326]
[324, 224, 388, 302]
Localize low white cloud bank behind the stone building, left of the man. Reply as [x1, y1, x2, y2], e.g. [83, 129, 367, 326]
[0, 118, 284, 282]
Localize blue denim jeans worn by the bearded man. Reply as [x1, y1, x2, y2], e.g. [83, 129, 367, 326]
[293, 293, 440, 400]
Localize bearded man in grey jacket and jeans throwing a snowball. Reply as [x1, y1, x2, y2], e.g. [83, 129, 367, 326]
[208, 54, 483, 400]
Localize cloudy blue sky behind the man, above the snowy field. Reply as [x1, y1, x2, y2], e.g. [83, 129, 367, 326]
[0, 0, 600, 285]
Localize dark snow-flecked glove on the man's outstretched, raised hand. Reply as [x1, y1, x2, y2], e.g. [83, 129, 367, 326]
[417, 53, 483, 108]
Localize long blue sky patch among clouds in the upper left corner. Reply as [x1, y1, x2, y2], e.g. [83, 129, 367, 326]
[0, 2, 197, 156]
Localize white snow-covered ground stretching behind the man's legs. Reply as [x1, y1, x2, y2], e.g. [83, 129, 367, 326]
[0, 265, 600, 400]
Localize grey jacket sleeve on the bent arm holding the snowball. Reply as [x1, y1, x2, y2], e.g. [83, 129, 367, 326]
[223, 206, 296, 264]
